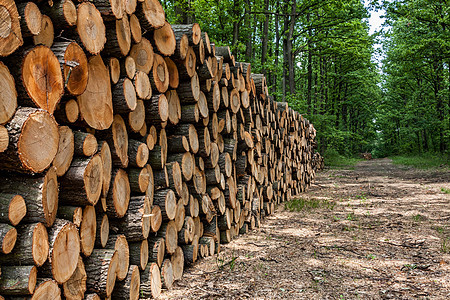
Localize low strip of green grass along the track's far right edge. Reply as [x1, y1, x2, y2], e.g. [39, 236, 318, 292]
[391, 153, 450, 169]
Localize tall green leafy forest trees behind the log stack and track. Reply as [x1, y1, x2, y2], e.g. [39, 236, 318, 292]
[162, 0, 450, 164]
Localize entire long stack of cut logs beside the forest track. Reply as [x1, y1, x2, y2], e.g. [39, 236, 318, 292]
[0, 0, 316, 299]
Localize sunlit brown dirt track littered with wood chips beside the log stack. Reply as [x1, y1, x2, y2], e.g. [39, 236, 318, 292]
[161, 159, 450, 299]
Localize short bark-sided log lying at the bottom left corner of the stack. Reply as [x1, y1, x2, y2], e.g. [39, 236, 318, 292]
[0, 266, 37, 296]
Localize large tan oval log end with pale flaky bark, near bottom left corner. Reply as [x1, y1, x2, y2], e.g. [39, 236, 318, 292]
[48, 219, 80, 284]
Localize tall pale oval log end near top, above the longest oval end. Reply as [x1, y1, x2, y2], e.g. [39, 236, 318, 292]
[77, 2, 106, 55]
